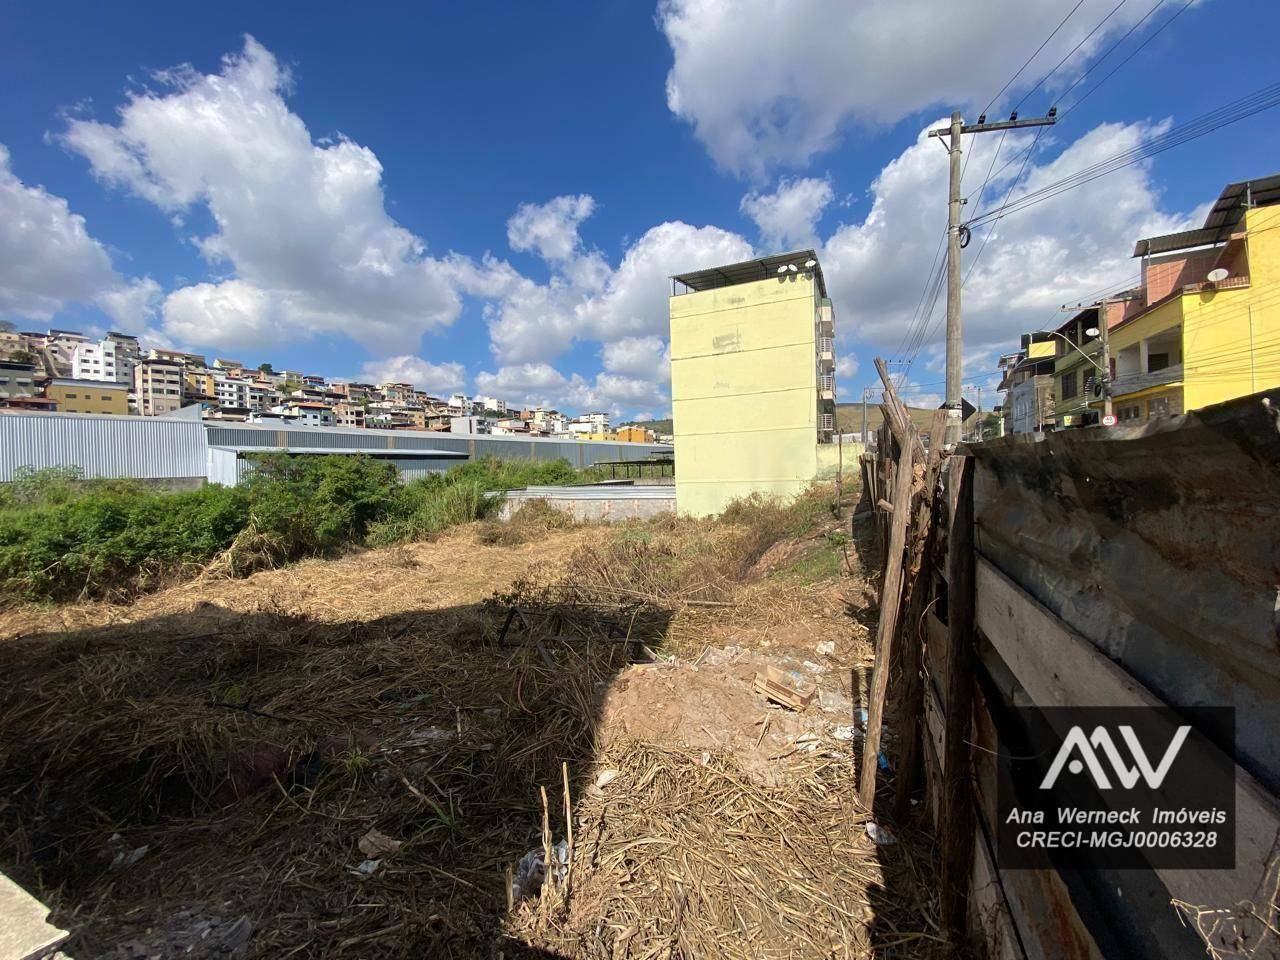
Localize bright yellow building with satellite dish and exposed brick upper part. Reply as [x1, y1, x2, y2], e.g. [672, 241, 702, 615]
[1091, 175, 1280, 422]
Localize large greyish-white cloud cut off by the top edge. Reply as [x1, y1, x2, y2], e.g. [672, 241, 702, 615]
[658, 0, 1167, 179]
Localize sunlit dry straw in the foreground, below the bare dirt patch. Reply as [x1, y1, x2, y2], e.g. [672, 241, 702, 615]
[511, 742, 948, 960]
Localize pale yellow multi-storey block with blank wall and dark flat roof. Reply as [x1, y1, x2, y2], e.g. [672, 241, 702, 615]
[671, 250, 836, 516]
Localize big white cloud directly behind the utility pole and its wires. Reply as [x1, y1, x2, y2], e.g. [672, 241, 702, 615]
[822, 123, 1194, 353]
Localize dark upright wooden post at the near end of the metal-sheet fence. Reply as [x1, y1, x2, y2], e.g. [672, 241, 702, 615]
[940, 457, 975, 942]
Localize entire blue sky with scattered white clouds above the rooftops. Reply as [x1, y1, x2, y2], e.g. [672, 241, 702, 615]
[0, 0, 1280, 416]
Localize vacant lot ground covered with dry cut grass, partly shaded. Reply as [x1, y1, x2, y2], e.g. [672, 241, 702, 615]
[0, 513, 951, 960]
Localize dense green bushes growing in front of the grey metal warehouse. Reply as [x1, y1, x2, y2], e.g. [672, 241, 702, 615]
[0, 454, 596, 599]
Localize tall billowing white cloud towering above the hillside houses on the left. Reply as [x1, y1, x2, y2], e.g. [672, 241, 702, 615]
[61, 37, 461, 352]
